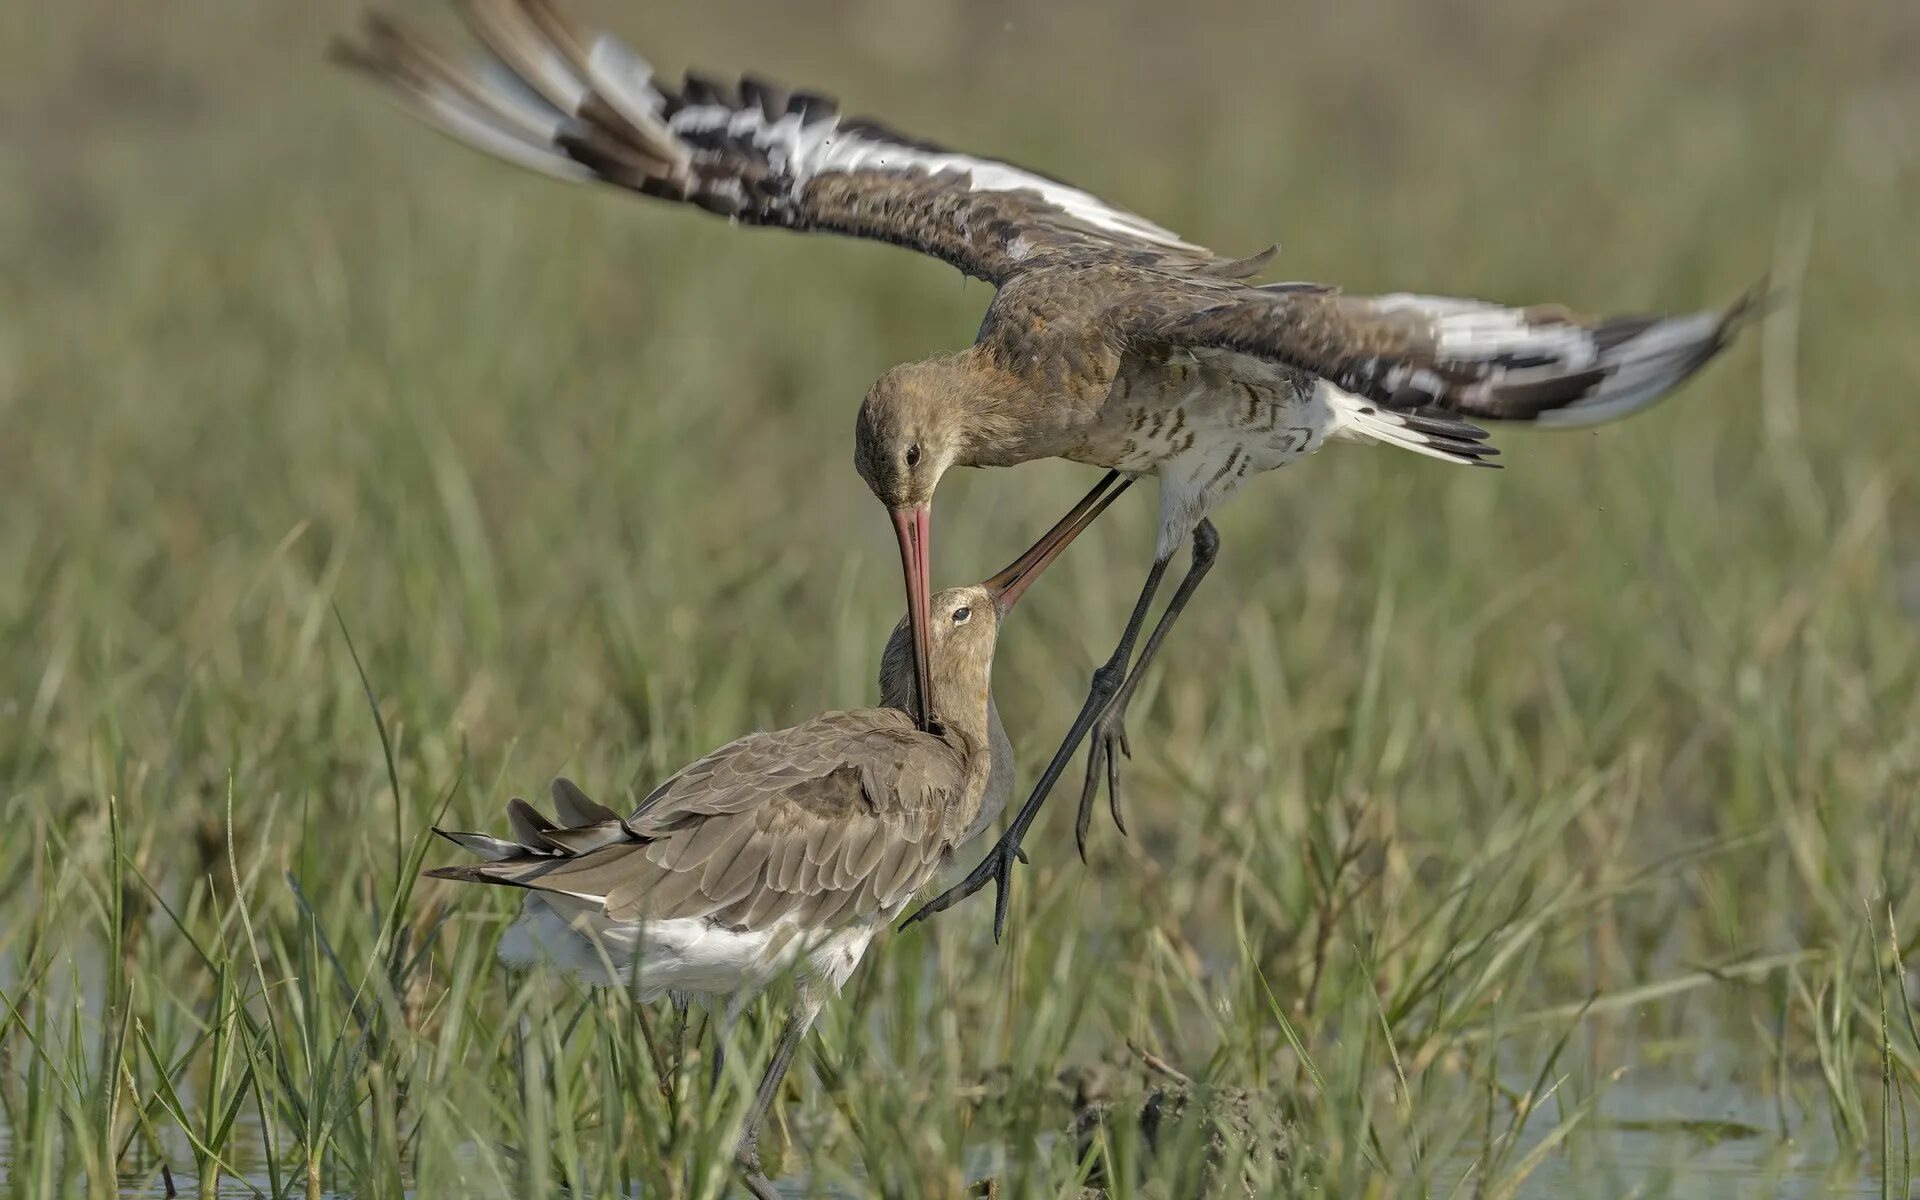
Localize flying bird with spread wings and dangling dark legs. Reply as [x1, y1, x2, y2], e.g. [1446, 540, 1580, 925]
[336, 0, 1751, 937]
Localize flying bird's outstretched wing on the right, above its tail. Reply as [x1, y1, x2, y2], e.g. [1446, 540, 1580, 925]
[1123, 284, 1759, 426]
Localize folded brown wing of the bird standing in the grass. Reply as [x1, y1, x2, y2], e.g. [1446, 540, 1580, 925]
[426, 708, 966, 929]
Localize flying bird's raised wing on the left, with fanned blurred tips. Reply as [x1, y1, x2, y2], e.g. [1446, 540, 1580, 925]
[336, 0, 1210, 282]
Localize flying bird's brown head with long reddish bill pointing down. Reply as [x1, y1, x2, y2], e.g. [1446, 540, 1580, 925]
[852, 361, 966, 728]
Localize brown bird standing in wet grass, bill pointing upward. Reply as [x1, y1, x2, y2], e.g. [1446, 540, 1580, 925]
[426, 474, 1125, 1198]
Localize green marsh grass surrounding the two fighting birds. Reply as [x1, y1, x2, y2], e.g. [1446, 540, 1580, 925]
[0, 0, 1920, 1198]
